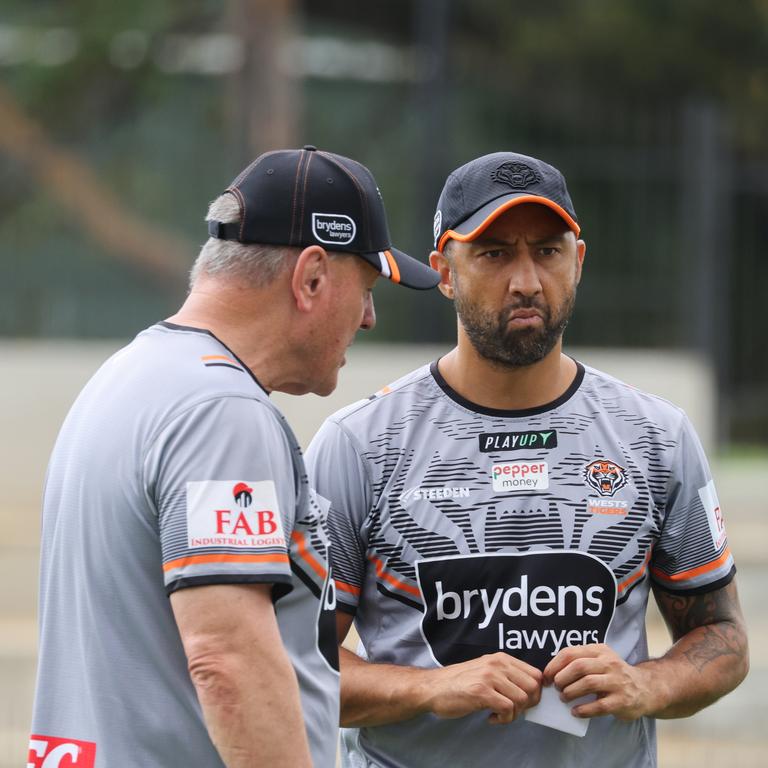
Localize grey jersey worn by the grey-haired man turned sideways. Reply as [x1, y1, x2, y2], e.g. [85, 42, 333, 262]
[28, 323, 338, 768]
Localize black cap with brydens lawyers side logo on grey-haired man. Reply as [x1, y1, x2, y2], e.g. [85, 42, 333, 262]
[208, 145, 440, 289]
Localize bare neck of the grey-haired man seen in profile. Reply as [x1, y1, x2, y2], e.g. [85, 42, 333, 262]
[168, 278, 291, 392]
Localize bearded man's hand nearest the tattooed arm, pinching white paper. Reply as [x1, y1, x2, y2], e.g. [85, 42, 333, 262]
[544, 643, 654, 720]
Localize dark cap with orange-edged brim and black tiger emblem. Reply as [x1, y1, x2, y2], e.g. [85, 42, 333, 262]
[434, 152, 580, 251]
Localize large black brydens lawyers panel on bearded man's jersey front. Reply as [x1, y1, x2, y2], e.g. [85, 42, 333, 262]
[416, 550, 616, 669]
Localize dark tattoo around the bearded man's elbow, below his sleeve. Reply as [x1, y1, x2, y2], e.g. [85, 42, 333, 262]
[654, 582, 747, 672]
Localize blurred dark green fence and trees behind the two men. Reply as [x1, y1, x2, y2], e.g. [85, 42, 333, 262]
[0, 0, 768, 444]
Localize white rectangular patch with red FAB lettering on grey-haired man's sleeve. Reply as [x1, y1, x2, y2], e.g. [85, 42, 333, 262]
[187, 480, 285, 549]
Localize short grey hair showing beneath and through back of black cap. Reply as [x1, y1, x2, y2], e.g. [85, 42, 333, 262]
[189, 192, 301, 288]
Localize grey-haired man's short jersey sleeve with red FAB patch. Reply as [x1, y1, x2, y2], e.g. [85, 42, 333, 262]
[144, 396, 296, 597]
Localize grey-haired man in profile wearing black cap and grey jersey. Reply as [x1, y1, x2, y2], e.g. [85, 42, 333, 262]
[27, 147, 439, 768]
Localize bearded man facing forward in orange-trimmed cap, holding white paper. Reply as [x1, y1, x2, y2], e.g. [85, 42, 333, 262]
[308, 152, 747, 768]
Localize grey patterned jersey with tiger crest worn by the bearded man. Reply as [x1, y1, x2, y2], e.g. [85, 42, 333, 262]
[307, 364, 734, 768]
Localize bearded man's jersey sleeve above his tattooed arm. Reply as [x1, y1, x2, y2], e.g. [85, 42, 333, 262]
[651, 417, 736, 594]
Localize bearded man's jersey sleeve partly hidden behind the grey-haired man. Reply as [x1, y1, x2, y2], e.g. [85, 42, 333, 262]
[305, 419, 371, 614]
